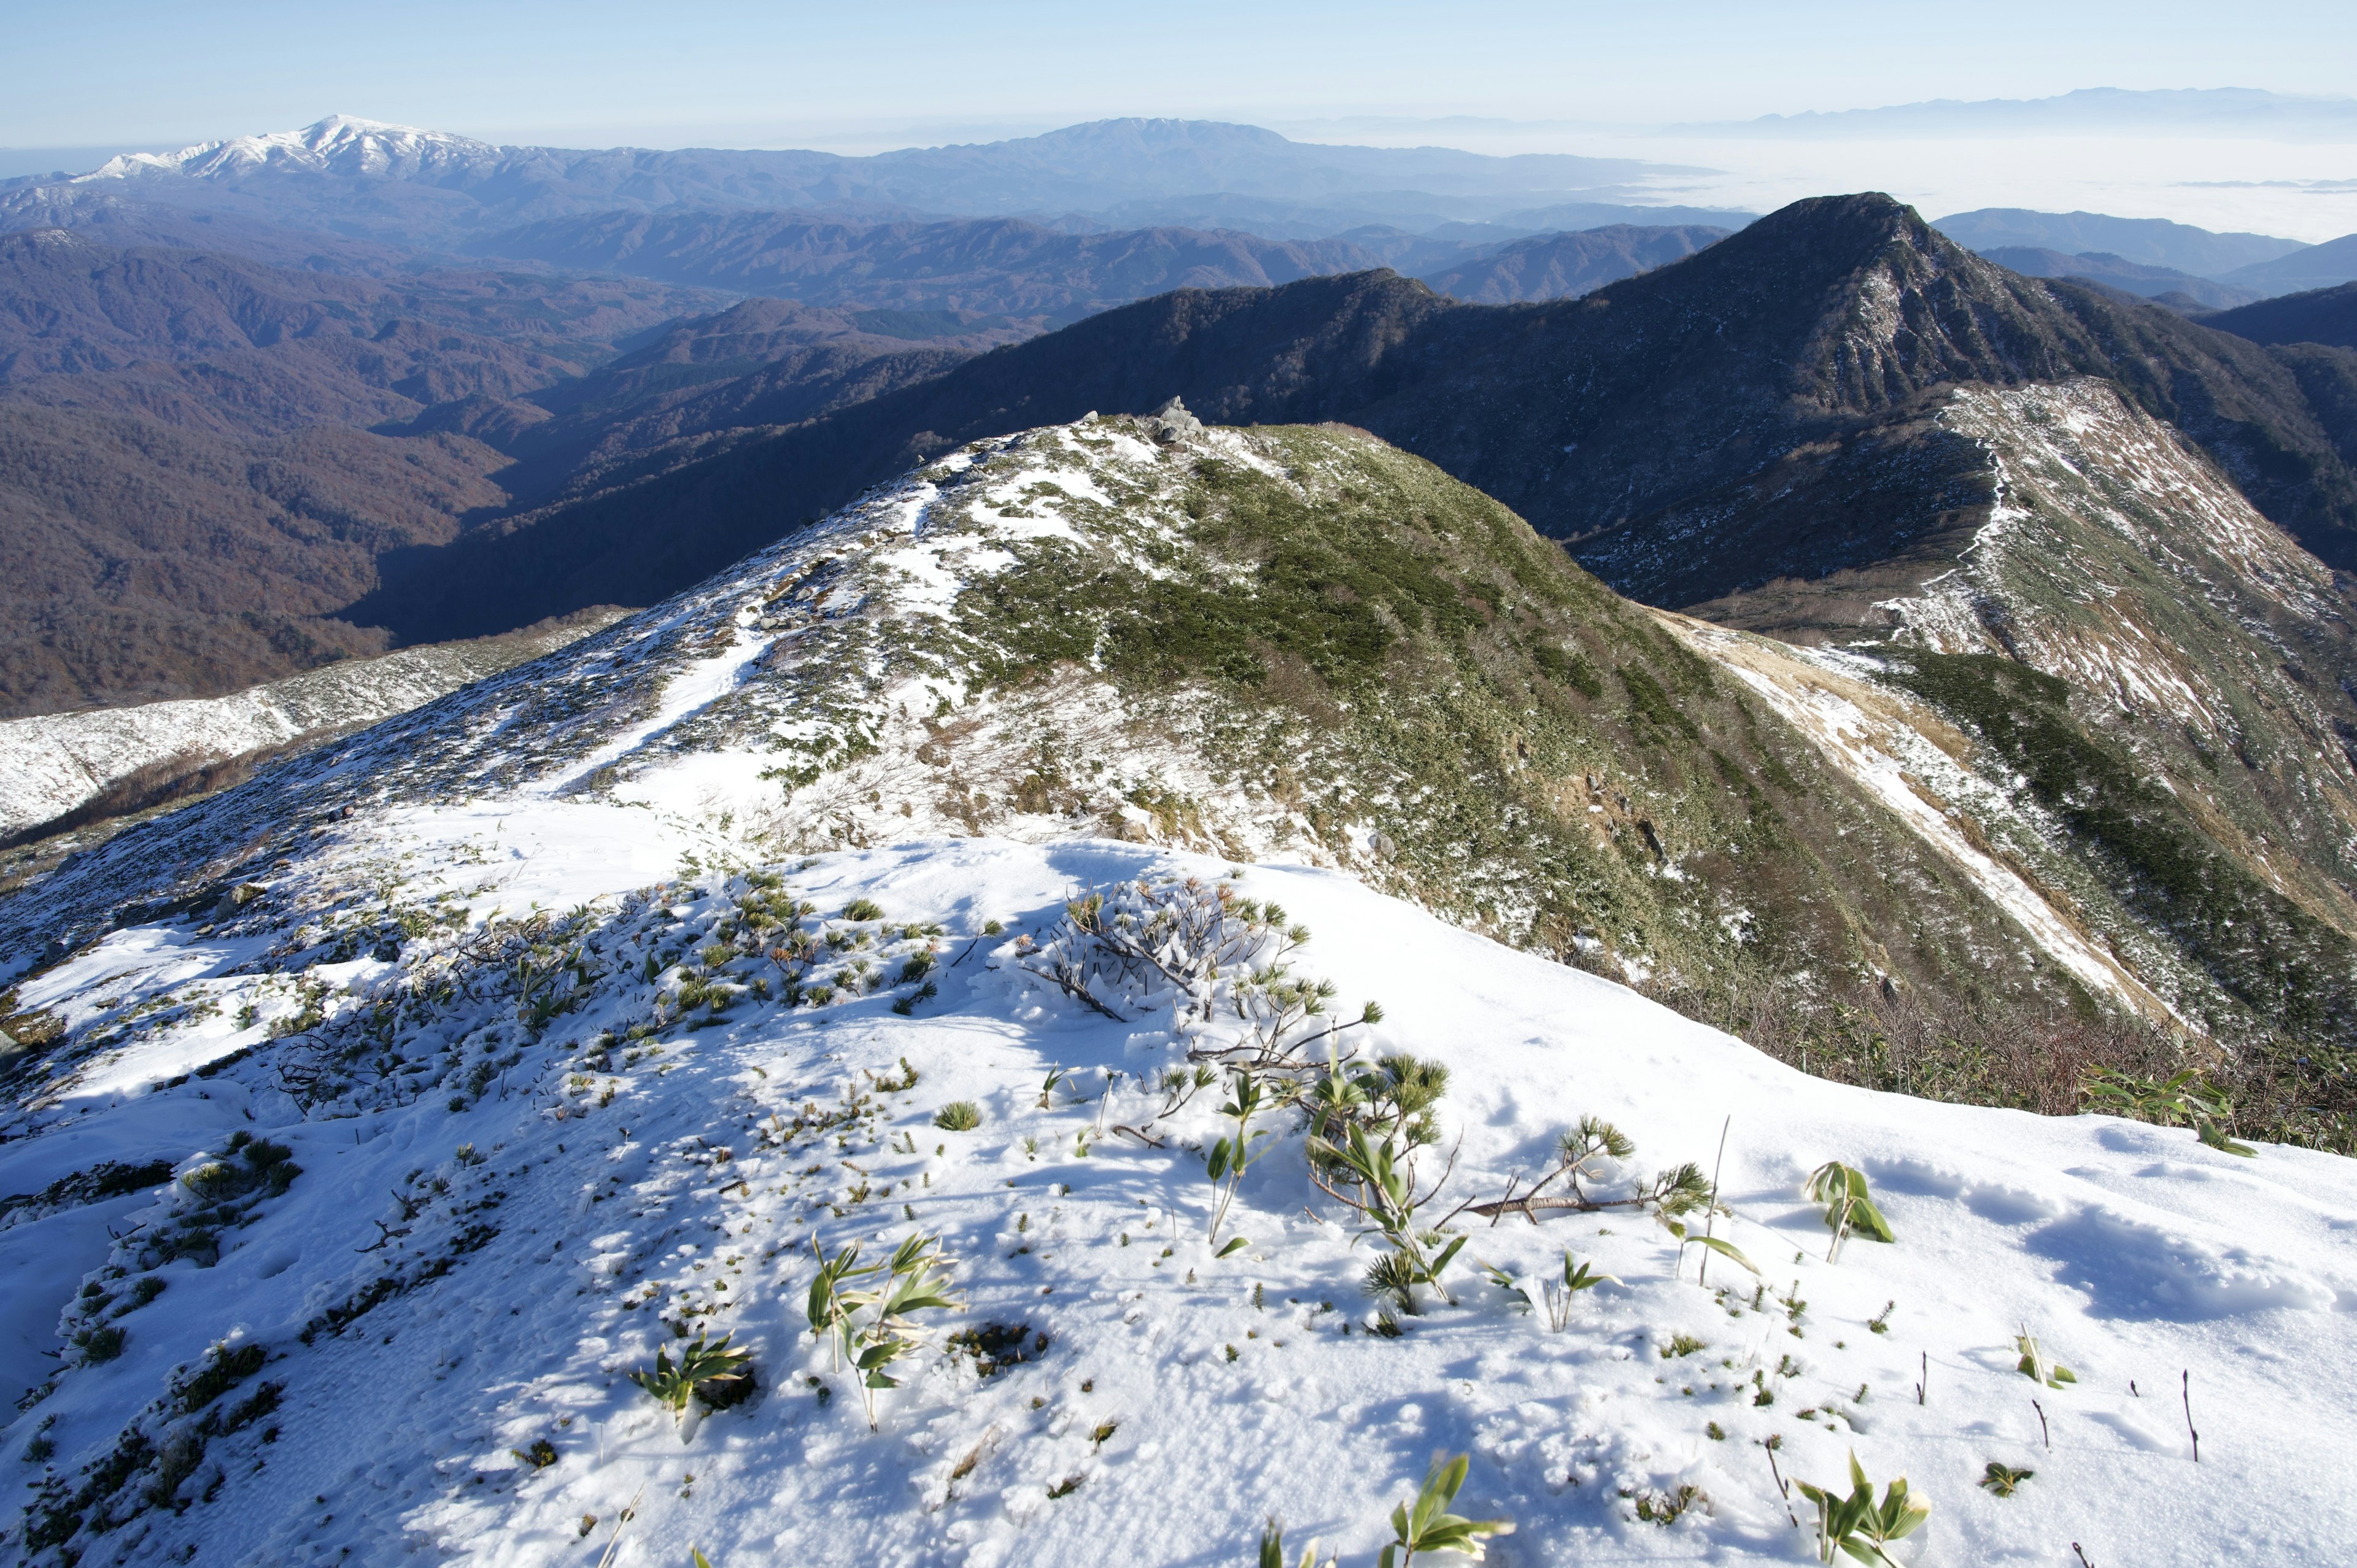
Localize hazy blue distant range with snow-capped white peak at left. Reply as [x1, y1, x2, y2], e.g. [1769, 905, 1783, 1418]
[0, 115, 1706, 250]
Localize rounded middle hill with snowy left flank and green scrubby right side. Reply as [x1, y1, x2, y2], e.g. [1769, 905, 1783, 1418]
[0, 417, 2140, 1023]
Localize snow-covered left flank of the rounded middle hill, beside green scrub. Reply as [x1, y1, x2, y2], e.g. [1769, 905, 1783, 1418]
[0, 417, 1322, 962]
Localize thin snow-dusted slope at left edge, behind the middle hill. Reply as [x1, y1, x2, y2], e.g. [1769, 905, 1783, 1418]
[0, 613, 611, 840]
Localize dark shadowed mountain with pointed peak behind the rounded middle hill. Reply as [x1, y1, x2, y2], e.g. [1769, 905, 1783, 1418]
[349, 196, 2357, 636]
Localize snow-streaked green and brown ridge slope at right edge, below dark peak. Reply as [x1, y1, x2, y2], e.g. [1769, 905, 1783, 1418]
[1687, 377, 2357, 1046]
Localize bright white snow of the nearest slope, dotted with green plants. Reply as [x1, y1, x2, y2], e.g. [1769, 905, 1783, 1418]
[0, 830, 2357, 1566]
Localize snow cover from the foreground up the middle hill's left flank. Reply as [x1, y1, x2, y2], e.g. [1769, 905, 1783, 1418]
[0, 410, 2357, 1568]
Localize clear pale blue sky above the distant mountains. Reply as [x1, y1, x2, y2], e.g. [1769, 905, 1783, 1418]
[0, 0, 2357, 151]
